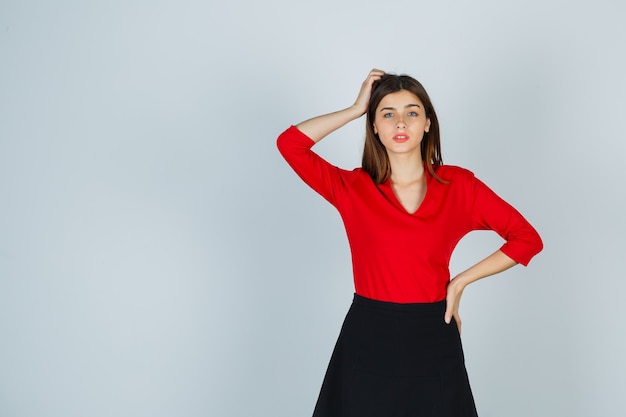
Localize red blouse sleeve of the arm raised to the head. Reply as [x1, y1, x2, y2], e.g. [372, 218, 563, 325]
[276, 126, 358, 207]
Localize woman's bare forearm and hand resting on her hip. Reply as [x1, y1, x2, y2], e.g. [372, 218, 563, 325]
[444, 250, 517, 333]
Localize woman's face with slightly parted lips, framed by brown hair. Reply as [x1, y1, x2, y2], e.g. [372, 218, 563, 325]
[374, 90, 430, 159]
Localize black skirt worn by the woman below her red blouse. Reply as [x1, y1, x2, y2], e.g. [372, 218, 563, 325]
[313, 294, 477, 417]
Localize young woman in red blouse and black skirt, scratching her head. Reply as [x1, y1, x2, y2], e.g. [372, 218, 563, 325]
[278, 69, 542, 417]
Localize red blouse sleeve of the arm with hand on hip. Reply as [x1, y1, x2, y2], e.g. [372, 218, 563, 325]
[472, 177, 543, 266]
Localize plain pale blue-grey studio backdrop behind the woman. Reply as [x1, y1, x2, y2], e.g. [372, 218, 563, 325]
[0, 0, 626, 417]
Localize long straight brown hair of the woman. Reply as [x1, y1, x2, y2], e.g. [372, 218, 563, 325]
[362, 74, 446, 184]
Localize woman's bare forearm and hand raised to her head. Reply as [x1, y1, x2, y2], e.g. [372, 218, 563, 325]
[296, 69, 385, 143]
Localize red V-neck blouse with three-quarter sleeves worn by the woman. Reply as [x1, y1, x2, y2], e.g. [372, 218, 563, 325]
[277, 126, 543, 303]
